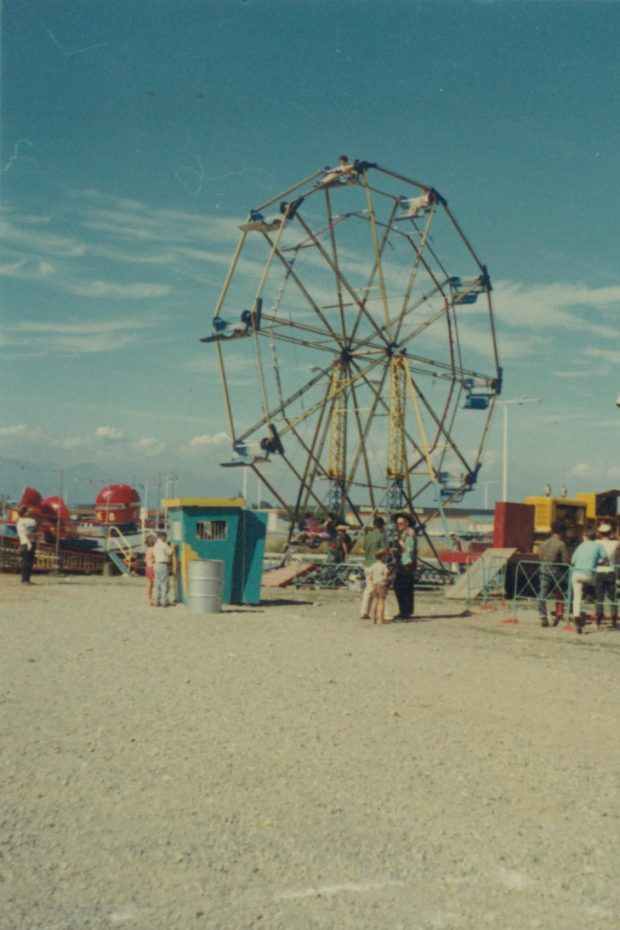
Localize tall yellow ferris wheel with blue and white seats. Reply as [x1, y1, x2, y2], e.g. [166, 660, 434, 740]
[202, 156, 501, 532]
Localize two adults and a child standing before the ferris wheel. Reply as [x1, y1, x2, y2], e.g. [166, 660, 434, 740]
[360, 513, 417, 623]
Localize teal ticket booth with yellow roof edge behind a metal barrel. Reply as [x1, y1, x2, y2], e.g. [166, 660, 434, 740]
[163, 497, 267, 604]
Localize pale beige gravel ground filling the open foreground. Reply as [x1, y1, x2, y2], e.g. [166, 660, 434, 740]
[0, 576, 620, 930]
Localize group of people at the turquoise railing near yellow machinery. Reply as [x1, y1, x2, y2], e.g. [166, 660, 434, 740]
[538, 521, 620, 633]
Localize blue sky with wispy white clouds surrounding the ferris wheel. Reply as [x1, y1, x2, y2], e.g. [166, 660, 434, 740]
[0, 0, 620, 505]
